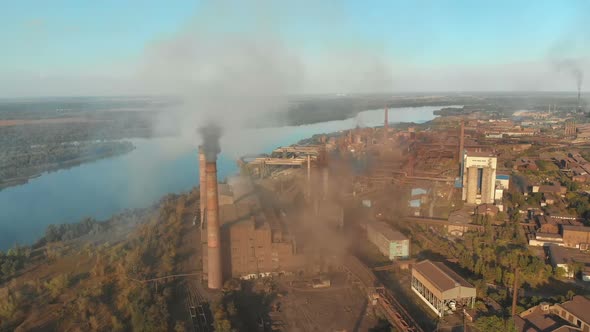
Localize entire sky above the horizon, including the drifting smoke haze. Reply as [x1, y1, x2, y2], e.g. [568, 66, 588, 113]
[0, 1, 590, 98]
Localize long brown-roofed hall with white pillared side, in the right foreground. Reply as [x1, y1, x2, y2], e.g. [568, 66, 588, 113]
[412, 260, 476, 317]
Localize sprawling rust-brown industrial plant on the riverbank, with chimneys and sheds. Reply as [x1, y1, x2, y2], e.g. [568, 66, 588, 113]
[191, 99, 590, 331]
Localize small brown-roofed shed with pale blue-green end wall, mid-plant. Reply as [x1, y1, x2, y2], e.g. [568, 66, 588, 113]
[367, 221, 410, 261]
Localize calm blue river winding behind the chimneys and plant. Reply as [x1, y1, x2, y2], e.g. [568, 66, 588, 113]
[0, 107, 448, 250]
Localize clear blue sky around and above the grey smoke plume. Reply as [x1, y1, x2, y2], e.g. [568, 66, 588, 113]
[0, 0, 590, 96]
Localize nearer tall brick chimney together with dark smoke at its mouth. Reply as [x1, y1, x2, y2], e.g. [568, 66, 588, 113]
[199, 124, 223, 289]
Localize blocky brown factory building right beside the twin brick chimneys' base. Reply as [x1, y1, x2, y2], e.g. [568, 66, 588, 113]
[202, 172, 305, 280]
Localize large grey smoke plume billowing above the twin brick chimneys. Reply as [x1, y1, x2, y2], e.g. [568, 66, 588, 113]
[140, 1, 392, 157]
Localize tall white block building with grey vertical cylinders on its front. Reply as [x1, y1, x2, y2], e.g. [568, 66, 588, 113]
[462, 150, 498, 204]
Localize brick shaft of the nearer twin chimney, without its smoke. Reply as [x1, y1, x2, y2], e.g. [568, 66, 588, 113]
[205, 160, 223, 289]
